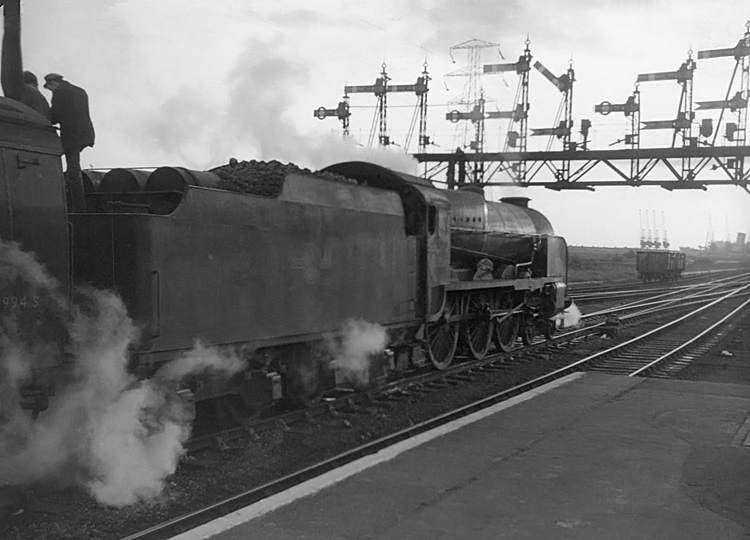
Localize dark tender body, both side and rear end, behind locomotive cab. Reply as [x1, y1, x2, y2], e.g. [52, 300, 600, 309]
[76, 177, 417, 351]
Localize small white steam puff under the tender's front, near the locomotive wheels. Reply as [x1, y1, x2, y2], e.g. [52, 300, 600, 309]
[328, 320, 388, 386]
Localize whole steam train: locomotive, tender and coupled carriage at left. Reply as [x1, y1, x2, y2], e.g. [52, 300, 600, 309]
[0, 98, 570, 412]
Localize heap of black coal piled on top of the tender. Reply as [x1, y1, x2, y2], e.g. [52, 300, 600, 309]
[210, 158, 357, 197]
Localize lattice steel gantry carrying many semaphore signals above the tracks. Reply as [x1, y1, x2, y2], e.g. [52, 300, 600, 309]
[314, 25, 750, 194]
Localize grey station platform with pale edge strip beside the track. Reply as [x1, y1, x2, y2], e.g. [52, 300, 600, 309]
[175, 373, 750, 540]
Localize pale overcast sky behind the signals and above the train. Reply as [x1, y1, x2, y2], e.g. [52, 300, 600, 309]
[13, 0, 750, 247]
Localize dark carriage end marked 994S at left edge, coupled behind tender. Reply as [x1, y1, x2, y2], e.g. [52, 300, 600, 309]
[0, 97, 69, 374]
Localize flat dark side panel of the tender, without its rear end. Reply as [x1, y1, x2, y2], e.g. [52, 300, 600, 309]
[153, 186, 416, 348]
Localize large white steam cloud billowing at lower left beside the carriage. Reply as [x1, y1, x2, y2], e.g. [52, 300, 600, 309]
[0, 242, 244, 506]
